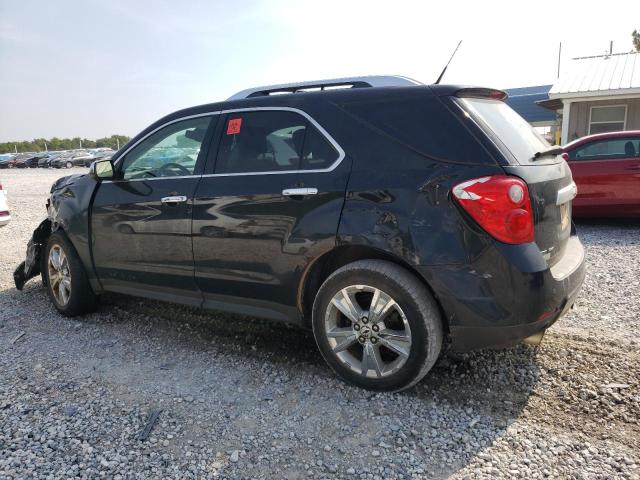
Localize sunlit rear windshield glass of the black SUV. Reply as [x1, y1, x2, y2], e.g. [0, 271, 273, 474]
[459, 98, 549, 164]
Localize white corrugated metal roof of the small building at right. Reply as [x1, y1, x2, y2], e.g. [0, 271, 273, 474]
[549, 52, 640, 98]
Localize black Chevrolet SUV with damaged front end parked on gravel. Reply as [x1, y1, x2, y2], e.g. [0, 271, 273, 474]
[15, 77, 584, 390]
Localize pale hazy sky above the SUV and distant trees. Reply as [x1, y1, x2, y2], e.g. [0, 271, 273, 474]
[0, 0, 640, 142]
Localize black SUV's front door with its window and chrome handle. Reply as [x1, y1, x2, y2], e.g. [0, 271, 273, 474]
[91, 115, 217, 305]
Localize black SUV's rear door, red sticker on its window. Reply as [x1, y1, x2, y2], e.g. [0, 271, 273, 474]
[193, 108, 349, 321]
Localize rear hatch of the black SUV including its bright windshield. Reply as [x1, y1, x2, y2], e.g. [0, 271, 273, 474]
[455, 94, 575, 267]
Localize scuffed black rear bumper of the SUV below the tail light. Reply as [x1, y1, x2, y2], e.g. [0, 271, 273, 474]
[421, 235, 585, 351]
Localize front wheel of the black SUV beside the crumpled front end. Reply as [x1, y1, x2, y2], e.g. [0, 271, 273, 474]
[40, 232, 98, 317]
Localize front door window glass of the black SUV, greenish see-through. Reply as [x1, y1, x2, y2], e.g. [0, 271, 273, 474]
[121, 117, 211, 180]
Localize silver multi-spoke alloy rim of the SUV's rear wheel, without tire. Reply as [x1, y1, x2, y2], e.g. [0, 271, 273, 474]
[324, 285, 411, 378]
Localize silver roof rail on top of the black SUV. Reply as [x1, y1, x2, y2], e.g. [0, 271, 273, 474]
[227, 75, 423, 100]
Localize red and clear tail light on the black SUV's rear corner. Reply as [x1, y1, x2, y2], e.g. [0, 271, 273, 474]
[453, 175, 533, 244]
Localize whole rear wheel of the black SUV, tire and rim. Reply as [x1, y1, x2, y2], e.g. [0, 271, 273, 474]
[312, 260, 443, 391]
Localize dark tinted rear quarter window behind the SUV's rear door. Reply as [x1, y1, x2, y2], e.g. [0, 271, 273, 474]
[342, 95, 495, 164]
